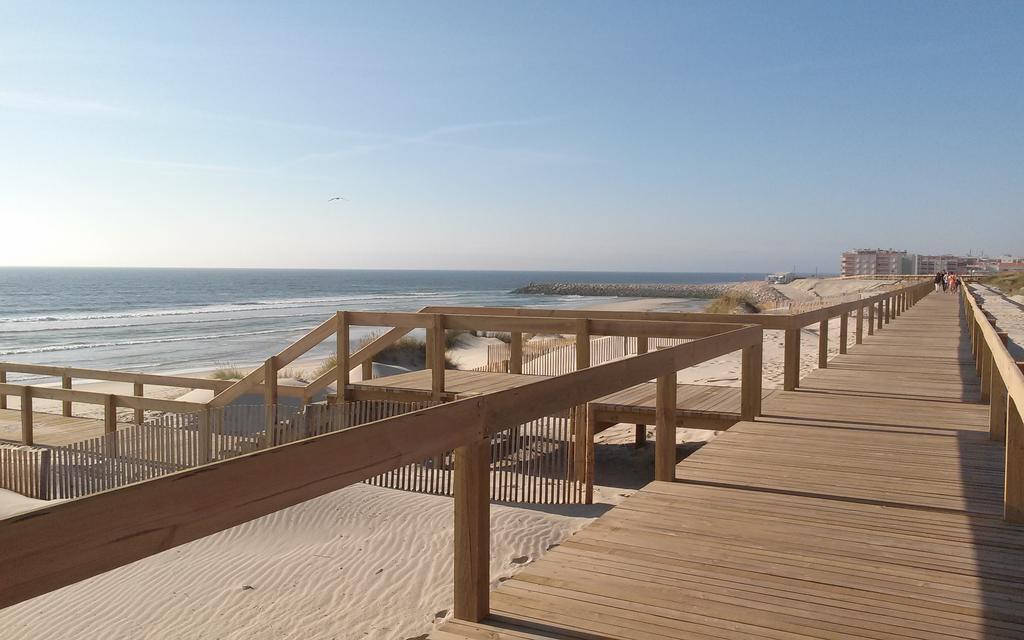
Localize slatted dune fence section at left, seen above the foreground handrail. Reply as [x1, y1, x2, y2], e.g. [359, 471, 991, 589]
[0, 400, 435, 500]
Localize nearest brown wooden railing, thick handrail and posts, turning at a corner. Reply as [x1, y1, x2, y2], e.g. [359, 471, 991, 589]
[0, 315, 763, 621]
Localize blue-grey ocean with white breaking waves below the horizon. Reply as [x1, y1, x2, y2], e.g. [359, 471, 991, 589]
[0, 267, 764, 382]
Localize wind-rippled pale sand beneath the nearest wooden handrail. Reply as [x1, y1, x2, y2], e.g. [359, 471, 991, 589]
[0, 484, 605, 640]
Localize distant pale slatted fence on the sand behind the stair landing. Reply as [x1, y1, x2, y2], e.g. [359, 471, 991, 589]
[475, 336, 691, 376]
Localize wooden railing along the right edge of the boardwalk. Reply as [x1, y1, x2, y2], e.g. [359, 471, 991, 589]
[961, 285, 1024, 522]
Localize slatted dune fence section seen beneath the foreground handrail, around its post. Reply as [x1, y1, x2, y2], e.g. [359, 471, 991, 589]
[367, 417, 584, 504]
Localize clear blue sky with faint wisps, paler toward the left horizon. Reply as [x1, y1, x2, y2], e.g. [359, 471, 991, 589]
[0, 1, 1024, 271]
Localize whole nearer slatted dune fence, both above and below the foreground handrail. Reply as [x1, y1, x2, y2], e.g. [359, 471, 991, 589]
[0, 400, 585, 504]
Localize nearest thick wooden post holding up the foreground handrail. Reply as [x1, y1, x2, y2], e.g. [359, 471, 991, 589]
[453, 438, 490, 623]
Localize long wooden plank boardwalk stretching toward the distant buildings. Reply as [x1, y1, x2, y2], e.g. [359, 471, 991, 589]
[430, 295, 1024, 640]
